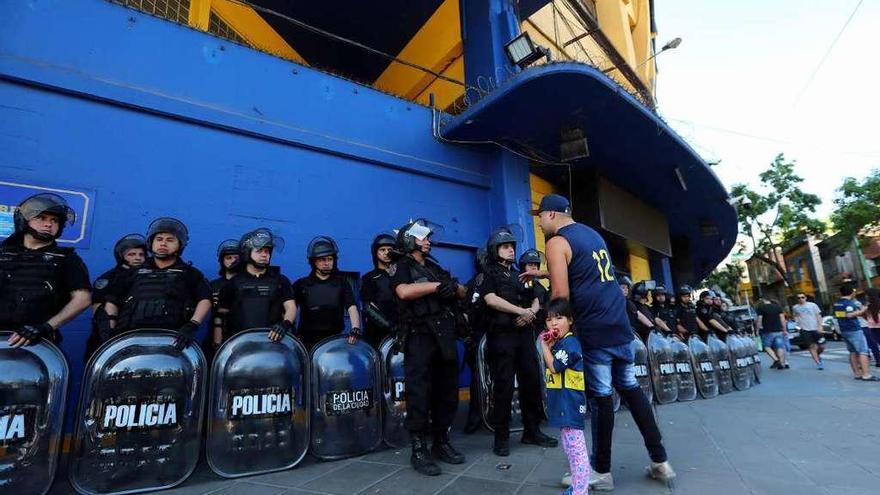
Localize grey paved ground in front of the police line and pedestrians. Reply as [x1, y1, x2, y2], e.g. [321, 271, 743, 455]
[51, 342, 880, 495]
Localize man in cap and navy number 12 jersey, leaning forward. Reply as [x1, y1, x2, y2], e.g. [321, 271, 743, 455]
[523, 194, 675, 491]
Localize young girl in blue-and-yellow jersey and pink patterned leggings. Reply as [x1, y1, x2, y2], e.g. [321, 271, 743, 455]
[541, 299, 590, 495]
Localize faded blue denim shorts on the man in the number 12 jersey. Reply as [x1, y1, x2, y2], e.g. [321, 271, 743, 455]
[584, 344, 639, 397]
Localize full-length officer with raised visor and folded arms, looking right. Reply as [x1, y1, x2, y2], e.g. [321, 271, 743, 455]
[390, 218, 465, 476]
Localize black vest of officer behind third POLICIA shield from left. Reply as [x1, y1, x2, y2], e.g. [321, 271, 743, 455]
[229, 274, 284, 335]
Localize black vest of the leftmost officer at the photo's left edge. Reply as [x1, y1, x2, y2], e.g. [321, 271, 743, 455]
[0, 246, 73, 328]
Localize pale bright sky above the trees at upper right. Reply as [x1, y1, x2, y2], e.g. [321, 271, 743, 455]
[655, 0, 880, 219]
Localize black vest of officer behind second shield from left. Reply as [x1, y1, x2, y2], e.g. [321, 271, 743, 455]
[119, 267, 192, 331]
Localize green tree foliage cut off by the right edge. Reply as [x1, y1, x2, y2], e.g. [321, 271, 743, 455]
[831, 169, 880, 239]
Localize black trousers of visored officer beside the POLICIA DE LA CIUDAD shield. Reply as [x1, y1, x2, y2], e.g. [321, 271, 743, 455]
[403, 332, 458, 434]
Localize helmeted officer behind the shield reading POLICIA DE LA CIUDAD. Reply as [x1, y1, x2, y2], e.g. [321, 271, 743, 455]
[293, 236, 362, 351]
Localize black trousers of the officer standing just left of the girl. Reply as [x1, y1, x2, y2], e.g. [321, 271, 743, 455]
[486, 326, 544, 435]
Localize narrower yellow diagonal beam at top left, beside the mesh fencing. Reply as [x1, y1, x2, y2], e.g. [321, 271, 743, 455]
[206, 0, 306, 65]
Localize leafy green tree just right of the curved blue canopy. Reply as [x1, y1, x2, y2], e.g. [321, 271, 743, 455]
[731, 153, 825, 287]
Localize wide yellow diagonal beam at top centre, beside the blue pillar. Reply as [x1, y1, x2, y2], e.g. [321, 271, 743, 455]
[375, 0, 464, 104]
